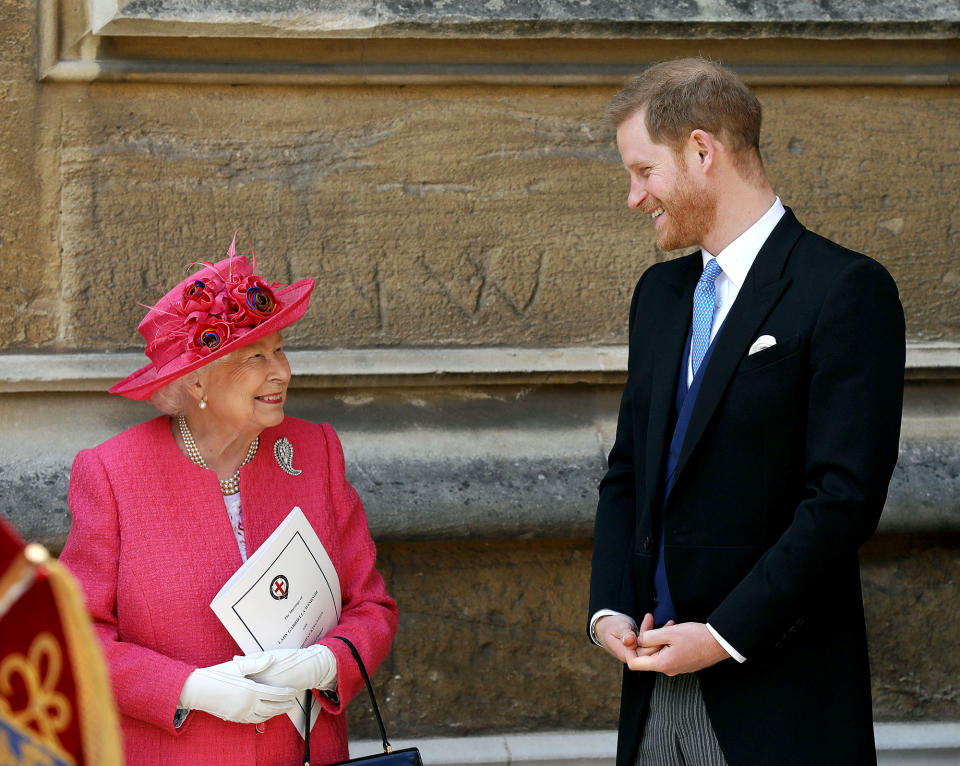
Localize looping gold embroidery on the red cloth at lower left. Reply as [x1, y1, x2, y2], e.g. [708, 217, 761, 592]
[0, 632, 73, 752]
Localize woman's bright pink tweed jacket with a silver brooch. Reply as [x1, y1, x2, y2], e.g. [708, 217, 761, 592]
[61, 417, 397, 766]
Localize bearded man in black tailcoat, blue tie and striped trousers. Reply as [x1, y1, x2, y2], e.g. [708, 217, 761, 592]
[590, 59, 905, 766]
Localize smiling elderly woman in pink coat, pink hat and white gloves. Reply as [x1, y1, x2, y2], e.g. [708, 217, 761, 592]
[61, 237, 397, 766]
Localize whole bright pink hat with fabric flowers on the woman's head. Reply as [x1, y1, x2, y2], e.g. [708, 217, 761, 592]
[110, 235, 313, 401]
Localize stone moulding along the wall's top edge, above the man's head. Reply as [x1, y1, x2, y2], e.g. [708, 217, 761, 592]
[39, 0, 960, 85]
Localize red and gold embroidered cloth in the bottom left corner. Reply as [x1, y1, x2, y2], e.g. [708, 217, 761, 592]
[0, 518, 123, 766]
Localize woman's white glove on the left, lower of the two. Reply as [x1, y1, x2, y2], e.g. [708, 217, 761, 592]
[178, 658, 299, 723]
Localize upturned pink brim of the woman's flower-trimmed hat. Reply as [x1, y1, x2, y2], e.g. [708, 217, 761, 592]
[110, 279, 314, 401]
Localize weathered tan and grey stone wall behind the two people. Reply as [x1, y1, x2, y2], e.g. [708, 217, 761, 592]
[0, 0, 960, 748]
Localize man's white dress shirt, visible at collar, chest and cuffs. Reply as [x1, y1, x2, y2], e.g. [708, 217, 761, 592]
[590, 197, 786, 662]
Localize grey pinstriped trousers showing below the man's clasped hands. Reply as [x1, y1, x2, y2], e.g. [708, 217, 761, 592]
[637, 673, 727, 766]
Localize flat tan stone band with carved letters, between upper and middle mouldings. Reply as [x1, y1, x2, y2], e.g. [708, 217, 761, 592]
[37, 87, 960, 349]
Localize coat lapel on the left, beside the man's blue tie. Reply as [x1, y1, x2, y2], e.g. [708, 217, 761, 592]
[644, 255, 703, 520]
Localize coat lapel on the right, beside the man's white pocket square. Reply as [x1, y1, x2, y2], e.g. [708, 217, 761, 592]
[675, 208, 804, 492]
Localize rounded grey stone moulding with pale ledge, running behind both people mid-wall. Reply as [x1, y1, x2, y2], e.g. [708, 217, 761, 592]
[0, 343, 960, 550]
